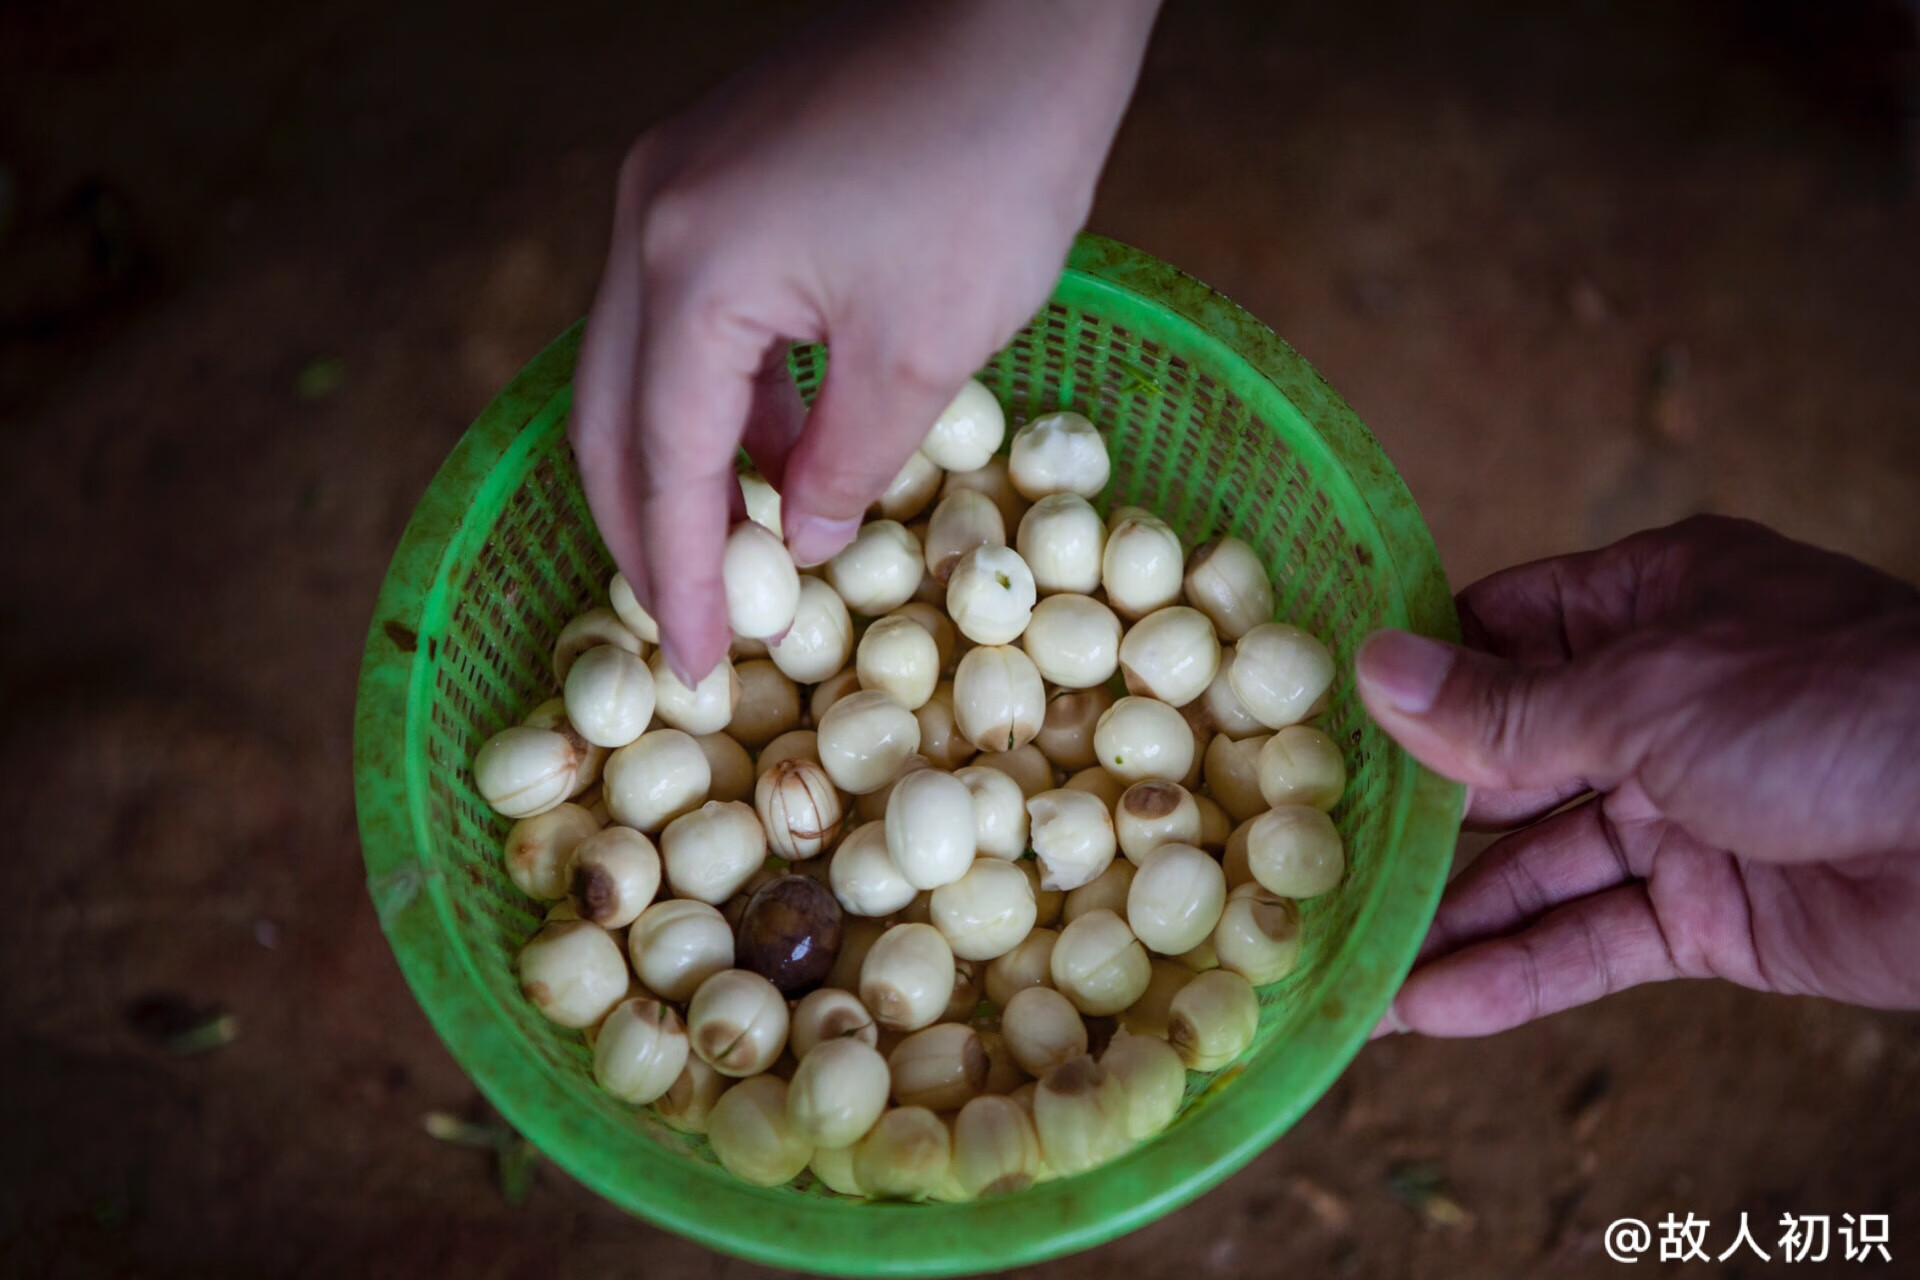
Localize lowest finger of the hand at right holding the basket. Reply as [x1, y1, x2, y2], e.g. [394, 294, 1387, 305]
[1375, 883, 1680, 1036]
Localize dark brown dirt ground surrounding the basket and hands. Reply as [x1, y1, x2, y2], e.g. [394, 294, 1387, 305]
[0, 0, 1920, 1280]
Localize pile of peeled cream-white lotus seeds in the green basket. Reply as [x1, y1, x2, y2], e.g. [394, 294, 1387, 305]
[474, 382, 1346, 1199]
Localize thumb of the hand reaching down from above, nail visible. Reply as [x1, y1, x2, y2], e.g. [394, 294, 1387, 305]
[781, 336, 968, 566]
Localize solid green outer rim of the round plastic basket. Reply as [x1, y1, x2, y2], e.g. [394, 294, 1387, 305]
[353, 236, 1465, 1276]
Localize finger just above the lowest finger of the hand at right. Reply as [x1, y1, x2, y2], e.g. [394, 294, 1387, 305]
[1415, 800, 1632, 963]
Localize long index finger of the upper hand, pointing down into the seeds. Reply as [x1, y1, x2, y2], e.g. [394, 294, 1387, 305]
[636, 285, 768, 685]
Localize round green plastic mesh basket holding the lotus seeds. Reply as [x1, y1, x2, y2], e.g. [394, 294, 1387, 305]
[353, 236, 1461, 1276]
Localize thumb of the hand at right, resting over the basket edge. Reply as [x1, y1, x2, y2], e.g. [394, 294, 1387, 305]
[1357, 631, 1649, 791]
